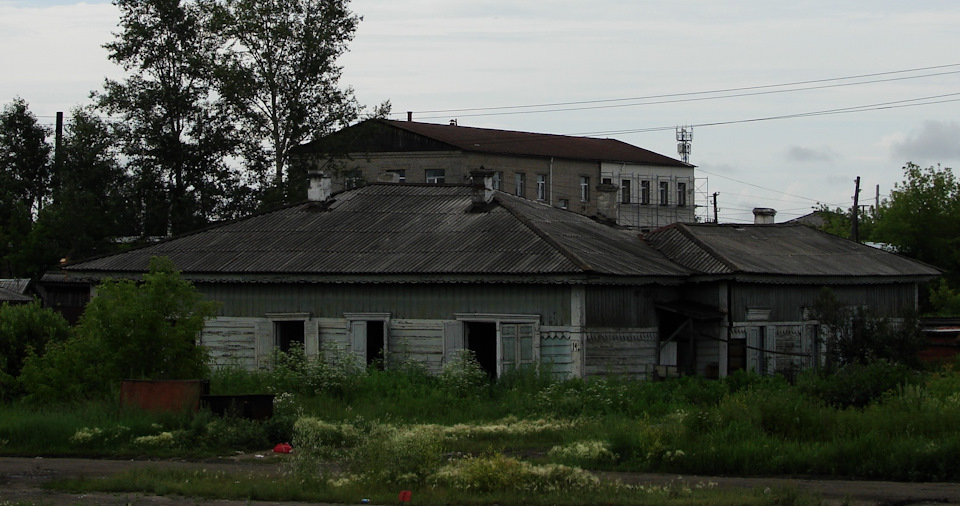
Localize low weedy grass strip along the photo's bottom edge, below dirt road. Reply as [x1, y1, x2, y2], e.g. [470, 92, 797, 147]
[48, 466, 820, 506]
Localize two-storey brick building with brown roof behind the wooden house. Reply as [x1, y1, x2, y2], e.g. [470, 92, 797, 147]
[298, 119, 695, 230]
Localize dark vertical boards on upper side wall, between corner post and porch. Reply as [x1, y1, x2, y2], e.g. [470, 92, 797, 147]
[585, 286, 677, 327]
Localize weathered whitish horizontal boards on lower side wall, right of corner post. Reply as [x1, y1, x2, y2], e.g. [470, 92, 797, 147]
[584, 327, 657, 379]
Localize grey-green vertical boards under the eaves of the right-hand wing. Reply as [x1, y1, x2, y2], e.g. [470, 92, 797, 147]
[731, 283, 916, 321]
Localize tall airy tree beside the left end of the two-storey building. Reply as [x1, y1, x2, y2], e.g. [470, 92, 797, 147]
[204, 0, 360, 196]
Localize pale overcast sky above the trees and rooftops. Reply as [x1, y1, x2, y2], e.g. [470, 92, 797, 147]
[0, 0, 960, 223]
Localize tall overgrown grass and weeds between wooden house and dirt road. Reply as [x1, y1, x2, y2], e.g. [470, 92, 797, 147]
[0, 350, 960, 482]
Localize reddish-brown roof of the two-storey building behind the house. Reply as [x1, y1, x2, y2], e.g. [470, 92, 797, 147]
[298, 119, 693, 167]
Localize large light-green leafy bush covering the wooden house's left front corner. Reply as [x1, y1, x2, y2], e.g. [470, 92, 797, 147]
[22, 257, 218, 401]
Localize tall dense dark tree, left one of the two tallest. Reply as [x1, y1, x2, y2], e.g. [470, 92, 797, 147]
[96, 0, 248, 235]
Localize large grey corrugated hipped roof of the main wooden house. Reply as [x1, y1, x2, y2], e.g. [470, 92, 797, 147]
[67, 184, 687, 276]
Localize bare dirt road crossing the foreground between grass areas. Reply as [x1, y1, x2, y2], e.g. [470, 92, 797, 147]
[0, 452, 960, 506]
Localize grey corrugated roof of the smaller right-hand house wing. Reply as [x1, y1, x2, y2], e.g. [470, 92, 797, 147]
[645, 224, 940, 276]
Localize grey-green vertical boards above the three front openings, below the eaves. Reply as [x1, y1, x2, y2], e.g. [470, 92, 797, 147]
[197, 283, 570, 325]
